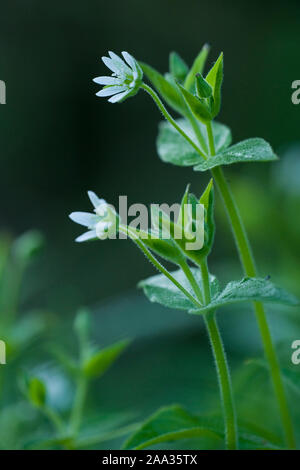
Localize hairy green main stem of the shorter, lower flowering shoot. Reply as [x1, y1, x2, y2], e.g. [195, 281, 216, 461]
[200, 259, 238, 450]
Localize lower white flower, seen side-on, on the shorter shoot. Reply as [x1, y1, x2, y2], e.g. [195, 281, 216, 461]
[69, 191, 119, 242]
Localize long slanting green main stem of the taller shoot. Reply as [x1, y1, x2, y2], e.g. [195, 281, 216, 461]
[207, 123, 296, 449]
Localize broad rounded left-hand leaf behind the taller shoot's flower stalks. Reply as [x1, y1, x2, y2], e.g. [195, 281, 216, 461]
[156, 119, 232, 166]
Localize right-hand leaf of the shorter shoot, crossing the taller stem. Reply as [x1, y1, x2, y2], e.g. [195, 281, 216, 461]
[190, 277, 299, 314]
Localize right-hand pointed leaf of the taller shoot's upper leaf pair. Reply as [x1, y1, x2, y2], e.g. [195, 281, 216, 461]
[194, 138, 277, 171]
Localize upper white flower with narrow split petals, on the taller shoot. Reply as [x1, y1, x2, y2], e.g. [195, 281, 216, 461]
[94, 51, 143, 103]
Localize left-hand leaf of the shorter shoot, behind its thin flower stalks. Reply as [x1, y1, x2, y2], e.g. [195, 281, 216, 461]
[138, 268, 219, 310]
